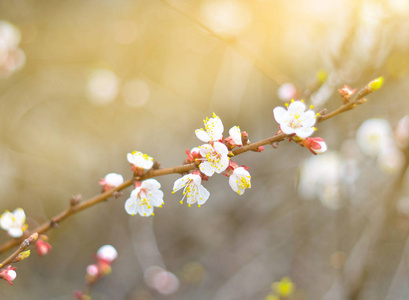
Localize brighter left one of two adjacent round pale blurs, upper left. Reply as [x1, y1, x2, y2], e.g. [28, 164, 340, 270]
[87, 69, 120, 105]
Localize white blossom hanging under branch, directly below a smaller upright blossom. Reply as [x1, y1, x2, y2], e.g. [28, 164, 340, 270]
[125, 179, 163, 217]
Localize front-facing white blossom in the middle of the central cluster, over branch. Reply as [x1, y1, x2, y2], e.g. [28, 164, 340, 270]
[199, 142, 229, 176]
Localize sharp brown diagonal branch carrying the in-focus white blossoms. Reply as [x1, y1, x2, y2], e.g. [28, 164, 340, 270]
[0, 79, 380, 253]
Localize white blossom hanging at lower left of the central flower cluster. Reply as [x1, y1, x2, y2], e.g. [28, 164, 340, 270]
[172, 174, 210, 207]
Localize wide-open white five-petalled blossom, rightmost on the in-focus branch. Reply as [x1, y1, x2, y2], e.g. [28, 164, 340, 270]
[274, 101, 316, 139]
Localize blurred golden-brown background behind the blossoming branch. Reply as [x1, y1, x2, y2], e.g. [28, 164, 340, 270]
[0, 0, 409, 300]
